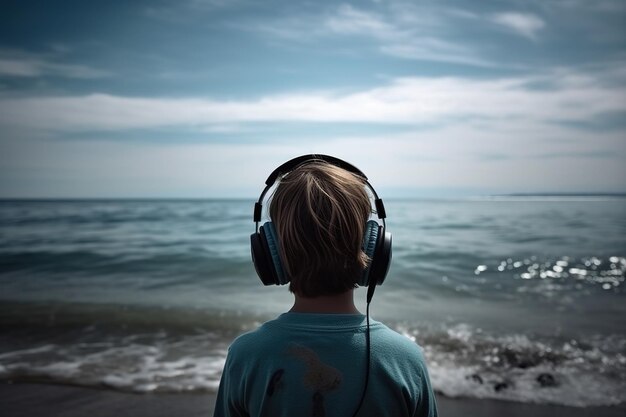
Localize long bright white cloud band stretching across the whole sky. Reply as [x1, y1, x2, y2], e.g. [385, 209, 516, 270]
[0, 70, 626, 131]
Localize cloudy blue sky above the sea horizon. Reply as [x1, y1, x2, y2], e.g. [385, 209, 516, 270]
[0, 0, 626, 198]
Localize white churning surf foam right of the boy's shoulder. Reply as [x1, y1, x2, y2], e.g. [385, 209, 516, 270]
[414, 325, 626, 407]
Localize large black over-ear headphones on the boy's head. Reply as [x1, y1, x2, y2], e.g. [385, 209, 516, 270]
[250, 154, 391, 290]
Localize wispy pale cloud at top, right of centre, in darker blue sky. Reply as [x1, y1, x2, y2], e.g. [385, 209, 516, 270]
[239, 3, 492, 67]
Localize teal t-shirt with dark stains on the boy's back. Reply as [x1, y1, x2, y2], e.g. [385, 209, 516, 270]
[214, 313, 437, 417]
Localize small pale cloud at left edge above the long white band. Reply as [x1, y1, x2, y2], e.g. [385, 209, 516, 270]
[0, 51, 111, 79]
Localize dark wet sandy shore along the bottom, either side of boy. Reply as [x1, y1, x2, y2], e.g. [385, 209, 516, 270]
[0, 382, 626, 417]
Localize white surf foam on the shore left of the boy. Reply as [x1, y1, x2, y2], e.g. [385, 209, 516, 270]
[0, 332, 228, 392]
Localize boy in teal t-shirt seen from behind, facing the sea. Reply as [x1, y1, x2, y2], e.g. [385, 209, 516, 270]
[214, 155, 437, 417]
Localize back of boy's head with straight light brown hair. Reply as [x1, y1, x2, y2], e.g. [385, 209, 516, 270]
[270, 161, 372, 297]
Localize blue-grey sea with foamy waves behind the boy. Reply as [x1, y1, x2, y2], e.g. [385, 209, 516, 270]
[0, 197, 626, 406]
